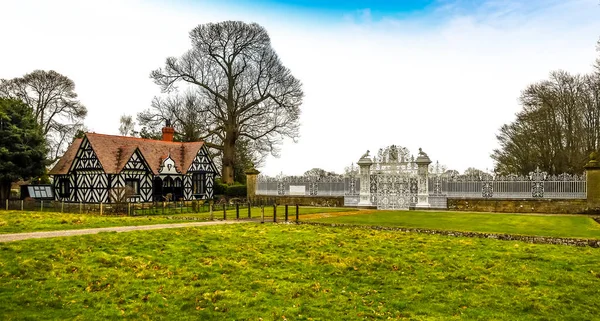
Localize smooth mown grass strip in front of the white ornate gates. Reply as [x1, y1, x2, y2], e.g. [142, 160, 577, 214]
[314, 211, 600, 239]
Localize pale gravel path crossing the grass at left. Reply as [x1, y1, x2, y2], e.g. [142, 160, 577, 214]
[0, 220, 251, 243]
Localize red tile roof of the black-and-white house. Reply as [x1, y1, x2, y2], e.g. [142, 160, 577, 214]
[49, 133, 213, 175]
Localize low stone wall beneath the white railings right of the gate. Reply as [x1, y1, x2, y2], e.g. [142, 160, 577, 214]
[448, 198, 597, 214]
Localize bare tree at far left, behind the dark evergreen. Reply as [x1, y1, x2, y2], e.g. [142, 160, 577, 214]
[0, 70, 87, 161]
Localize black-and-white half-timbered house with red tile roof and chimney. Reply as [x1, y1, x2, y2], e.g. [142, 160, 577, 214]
[49, 127, 218, 203]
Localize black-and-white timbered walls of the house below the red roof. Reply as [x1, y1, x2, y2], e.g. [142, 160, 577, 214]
[53, 137, 217, 203]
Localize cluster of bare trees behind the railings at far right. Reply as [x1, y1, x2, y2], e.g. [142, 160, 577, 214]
[491, 41, 600, 175]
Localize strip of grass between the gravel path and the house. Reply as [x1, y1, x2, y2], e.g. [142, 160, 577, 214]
[0, 206, 352, 234]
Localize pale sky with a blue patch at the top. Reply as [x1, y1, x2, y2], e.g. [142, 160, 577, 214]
[0, 0, 600, 175]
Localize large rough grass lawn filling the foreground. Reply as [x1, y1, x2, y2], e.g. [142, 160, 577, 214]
[0, 224, 600, 320]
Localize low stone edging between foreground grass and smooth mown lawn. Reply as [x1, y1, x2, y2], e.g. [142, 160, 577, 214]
[298, 221, 600, 248]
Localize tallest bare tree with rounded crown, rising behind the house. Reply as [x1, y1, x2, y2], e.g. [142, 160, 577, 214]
[151, 21, 304, 184]
